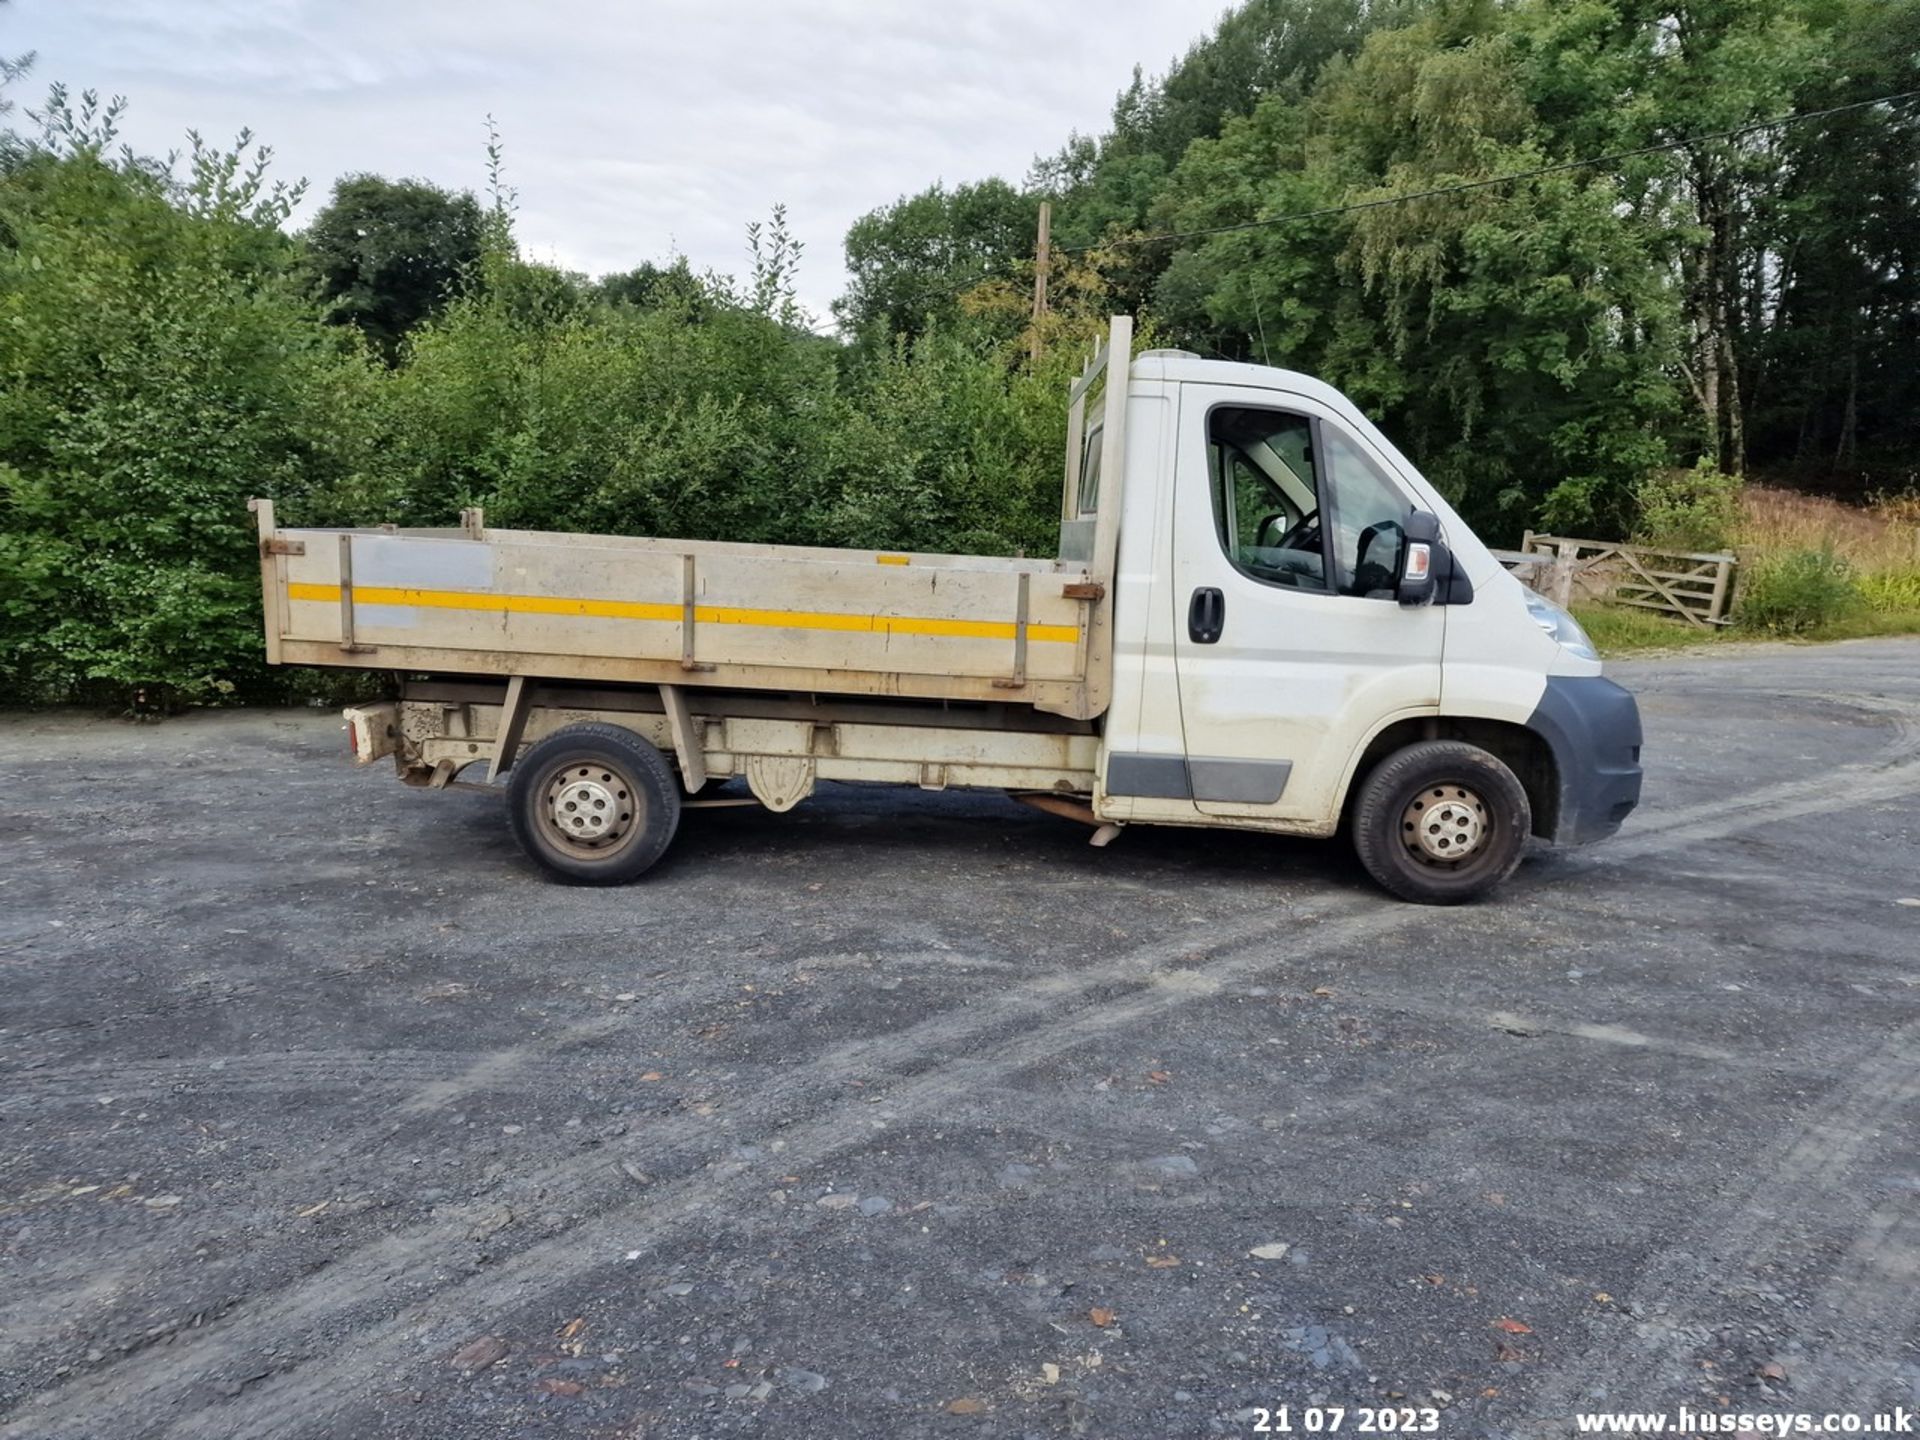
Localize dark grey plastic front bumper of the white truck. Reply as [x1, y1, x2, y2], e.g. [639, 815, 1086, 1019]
[1526, 676, 1640, 845]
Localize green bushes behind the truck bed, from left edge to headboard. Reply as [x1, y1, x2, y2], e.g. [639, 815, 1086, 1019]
[0, 85, 1071, 705]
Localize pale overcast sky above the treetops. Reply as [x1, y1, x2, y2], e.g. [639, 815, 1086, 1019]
[0, 0, 1223, 321]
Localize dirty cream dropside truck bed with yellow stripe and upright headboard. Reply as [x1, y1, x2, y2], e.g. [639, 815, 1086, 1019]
[253, 317, 1131, 720]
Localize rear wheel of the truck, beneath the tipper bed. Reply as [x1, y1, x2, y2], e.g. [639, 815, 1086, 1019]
[507, 724, 680, 885]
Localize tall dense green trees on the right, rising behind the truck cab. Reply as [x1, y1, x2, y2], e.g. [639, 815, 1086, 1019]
[847, 0, 1920, 536]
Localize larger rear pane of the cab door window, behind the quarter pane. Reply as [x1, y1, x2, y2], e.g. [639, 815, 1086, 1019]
[1208, 405, 1327, 591]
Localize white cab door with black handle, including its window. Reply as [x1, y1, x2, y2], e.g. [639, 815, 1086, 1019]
[1173, 384, 1446, 829]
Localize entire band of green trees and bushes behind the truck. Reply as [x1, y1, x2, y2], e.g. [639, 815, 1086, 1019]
[0, 0, 1920, 703]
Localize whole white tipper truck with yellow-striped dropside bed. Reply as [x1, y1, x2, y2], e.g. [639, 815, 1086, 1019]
[253, 317, 1640, 902]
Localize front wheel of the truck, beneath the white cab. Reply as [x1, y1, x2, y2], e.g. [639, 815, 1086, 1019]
[1354, 739, 1534, 904]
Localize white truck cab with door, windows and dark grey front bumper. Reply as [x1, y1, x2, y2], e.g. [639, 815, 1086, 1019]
[1062, 341, 1640, 899]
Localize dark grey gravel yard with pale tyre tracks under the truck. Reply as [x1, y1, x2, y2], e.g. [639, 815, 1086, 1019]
[0, 641, 1920, 1440]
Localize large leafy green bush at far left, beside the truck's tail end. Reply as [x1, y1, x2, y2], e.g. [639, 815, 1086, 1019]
[0, 150, 372, 707]
